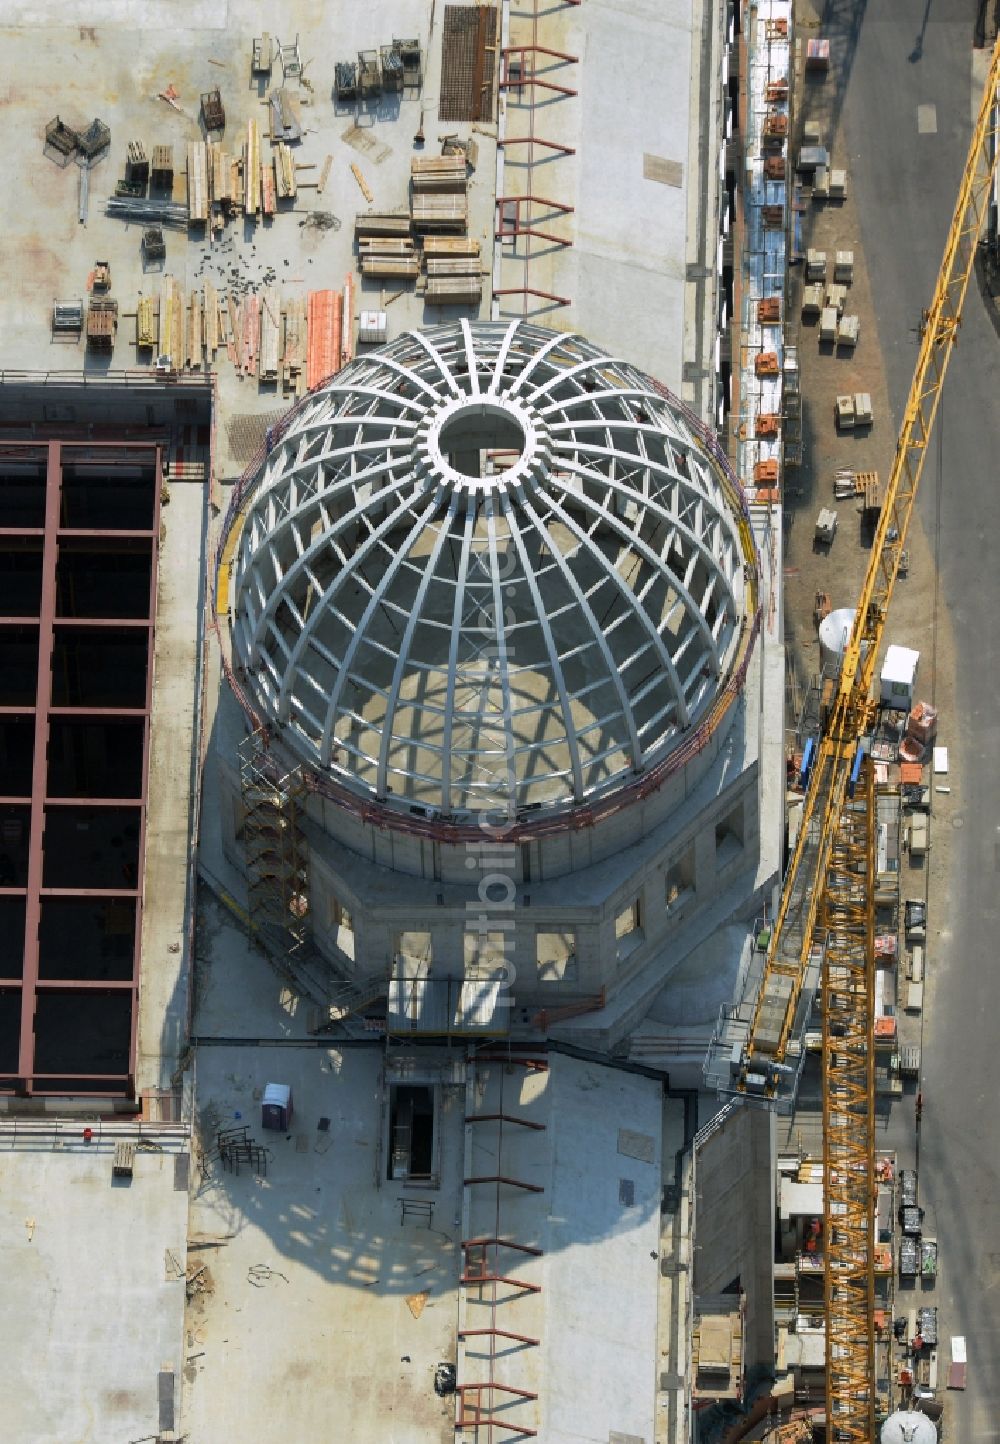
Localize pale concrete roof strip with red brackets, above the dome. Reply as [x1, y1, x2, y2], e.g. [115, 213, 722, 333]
[495, 0, 717, 410]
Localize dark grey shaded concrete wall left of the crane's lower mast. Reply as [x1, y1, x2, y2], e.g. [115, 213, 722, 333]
[694, 1103, 775, 1367]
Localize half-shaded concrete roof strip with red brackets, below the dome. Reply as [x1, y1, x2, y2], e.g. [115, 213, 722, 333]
[459, 1053, 662, 1444]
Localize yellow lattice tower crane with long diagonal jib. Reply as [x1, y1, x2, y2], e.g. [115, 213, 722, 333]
[733, 40, 1000, 1444]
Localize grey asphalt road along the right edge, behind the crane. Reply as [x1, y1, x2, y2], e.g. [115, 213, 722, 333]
[827, 0, 1000, 1444]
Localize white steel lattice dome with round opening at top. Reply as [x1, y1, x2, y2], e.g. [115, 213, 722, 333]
[234, 321, 752, 817]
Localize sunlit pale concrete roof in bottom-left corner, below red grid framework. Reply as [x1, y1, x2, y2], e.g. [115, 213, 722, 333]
[0, 1122, 187, 1444]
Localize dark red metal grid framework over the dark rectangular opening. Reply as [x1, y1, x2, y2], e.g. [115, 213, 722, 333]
[0, 440, 162, 1097]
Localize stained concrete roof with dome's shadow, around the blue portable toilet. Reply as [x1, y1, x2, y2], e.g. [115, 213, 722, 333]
[182, 1045, 463, 1444]
